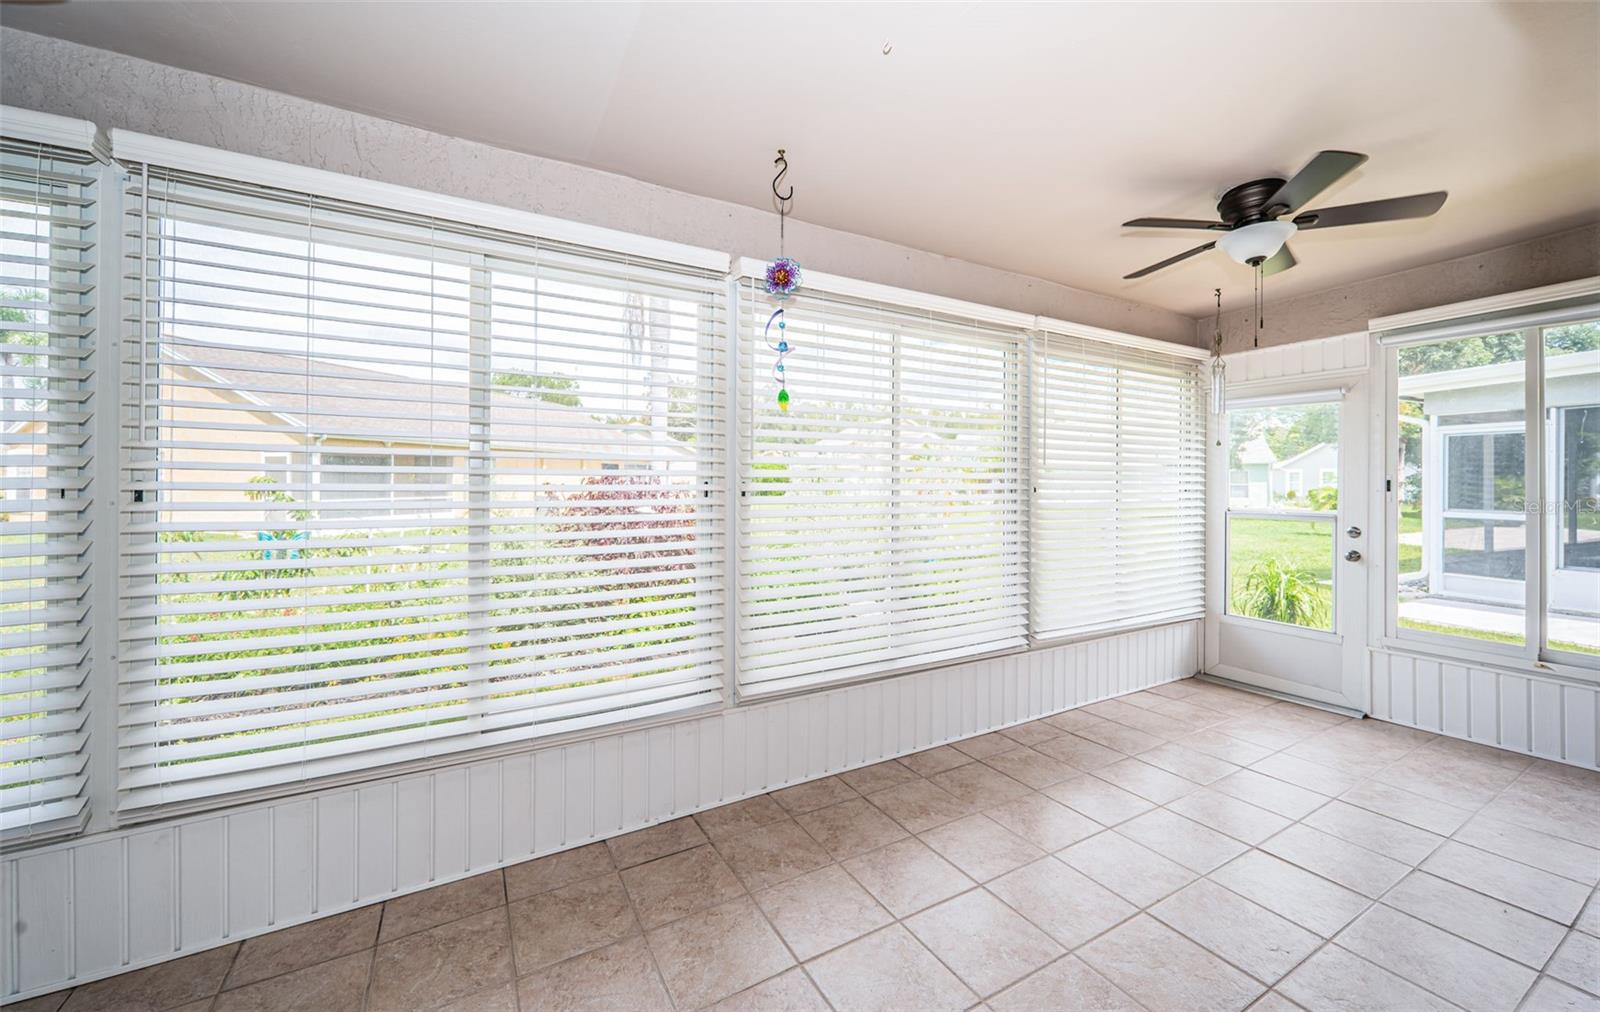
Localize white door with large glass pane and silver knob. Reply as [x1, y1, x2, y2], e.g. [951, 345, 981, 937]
[1206, 376, 1371, 713]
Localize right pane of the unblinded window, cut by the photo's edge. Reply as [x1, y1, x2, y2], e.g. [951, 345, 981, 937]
[1542, 322, 1600, 655]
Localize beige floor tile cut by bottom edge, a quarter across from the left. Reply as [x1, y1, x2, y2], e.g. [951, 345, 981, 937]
[366, 903, 512, 1012]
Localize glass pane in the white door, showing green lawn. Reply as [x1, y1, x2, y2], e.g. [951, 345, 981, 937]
[1226, 397, 1339, 631]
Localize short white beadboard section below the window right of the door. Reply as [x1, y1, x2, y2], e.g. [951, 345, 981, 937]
[1371, 650, 1600, 769]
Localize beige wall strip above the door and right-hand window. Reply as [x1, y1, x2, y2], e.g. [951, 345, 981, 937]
[1195, 224, 1600, 352]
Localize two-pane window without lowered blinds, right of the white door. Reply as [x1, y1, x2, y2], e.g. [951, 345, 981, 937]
[1381, 299, 1600, 659]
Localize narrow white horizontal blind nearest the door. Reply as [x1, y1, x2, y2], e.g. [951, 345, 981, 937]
[1032, 335, 1205, 637]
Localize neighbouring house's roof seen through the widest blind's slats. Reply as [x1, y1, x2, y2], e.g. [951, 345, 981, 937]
[162, 343, 693, 458]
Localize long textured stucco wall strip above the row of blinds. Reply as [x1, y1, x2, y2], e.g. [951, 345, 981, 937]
[0, 29, 1195, 344]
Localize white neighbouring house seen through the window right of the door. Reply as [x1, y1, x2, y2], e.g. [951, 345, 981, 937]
[1400, 351, 1600, 615]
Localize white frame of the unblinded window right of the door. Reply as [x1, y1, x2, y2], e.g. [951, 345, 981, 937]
[1368, 285, 1600, 684]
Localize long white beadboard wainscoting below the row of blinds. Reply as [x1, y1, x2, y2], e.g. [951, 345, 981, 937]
[0, 621, 1200, 999]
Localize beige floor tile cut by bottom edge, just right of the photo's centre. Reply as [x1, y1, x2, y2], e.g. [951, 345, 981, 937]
[806, 924, 978, 1012]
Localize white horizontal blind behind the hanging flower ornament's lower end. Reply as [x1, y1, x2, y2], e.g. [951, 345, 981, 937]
[738, 282, 1027, 693]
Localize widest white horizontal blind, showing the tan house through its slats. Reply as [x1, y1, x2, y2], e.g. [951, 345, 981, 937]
[120, 165, 726, 812]
